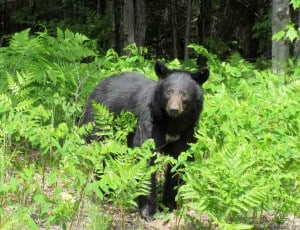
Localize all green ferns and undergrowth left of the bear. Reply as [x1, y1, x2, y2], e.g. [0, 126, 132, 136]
[0, 29, 153, 229]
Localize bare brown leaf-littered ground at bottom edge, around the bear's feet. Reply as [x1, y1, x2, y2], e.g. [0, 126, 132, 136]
[40, 201, 300, 230]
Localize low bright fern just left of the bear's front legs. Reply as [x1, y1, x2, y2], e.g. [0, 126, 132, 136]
[99, 141, 155, 209]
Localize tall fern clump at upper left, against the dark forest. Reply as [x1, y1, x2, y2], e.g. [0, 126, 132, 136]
[0, 29, 96, 106]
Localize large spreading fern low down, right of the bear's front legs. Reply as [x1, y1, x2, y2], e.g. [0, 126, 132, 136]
[180, 146, 272, 225]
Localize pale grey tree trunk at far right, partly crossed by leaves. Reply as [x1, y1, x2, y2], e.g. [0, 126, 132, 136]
[272, 0, 290, 73]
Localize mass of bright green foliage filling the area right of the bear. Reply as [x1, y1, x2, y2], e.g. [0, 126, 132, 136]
[179, 44, 300, 229]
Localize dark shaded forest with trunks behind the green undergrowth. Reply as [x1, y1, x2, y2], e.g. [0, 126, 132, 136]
[0, 0, 286, 60]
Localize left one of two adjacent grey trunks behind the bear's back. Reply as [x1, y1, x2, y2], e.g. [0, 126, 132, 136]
[120, 0, 135, 52]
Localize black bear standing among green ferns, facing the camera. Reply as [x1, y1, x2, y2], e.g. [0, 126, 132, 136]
[84, 60, 209, 219]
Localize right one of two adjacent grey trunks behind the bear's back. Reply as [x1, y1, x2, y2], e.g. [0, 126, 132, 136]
[134, 0, 146, 46]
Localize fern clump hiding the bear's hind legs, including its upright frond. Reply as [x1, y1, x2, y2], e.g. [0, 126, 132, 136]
[85, 103, 154, 209]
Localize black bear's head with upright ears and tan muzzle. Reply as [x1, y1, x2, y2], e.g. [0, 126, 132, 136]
[154, 60, 209, 118]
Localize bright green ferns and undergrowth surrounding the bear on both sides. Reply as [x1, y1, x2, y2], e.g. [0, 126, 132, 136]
[0, 29, 300, 229]
